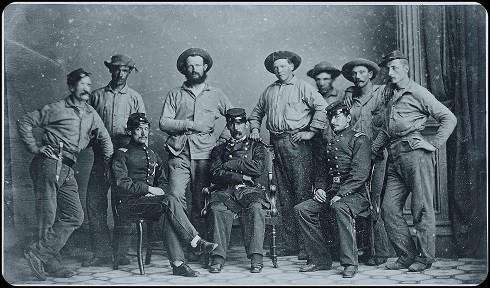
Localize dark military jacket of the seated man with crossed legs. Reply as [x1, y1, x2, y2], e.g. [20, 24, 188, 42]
[112, 141, 168, 202]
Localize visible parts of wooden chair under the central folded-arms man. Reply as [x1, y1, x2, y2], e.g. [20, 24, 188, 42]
[201, 142, 280, 268]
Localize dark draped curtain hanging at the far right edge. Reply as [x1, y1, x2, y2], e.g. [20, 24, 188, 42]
[421, 5, 487, 258]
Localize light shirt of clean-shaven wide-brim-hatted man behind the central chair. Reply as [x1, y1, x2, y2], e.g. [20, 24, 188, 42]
[250, 76, 327, 133]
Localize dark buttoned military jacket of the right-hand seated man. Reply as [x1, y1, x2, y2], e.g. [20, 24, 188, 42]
[315, 127, 371, 197]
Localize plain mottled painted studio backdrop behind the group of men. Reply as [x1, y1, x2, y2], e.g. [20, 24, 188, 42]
[3, 3, 486, 258]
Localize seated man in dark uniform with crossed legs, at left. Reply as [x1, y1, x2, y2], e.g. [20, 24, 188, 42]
[112, 113, 218, 277]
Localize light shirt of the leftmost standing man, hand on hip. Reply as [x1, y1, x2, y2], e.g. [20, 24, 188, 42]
[17, 96, 113, 161]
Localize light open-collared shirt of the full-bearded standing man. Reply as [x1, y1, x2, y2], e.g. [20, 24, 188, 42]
[159, 83, 233, 159]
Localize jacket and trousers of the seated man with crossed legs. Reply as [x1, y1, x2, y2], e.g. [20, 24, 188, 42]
[112, 141, 198, 263]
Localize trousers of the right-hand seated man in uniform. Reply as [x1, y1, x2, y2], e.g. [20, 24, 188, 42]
[294, 193, 369, 266]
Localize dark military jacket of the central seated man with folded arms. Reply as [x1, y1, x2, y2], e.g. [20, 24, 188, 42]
[210, 138, 268, 212]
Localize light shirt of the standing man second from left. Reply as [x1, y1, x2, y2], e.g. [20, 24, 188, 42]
[89, 85, 145, 139]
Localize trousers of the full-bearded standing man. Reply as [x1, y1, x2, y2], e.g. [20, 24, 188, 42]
[168, 143, 210, 235]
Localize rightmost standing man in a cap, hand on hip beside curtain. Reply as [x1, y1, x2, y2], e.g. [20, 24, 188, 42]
[373, 50, 457, 272]
